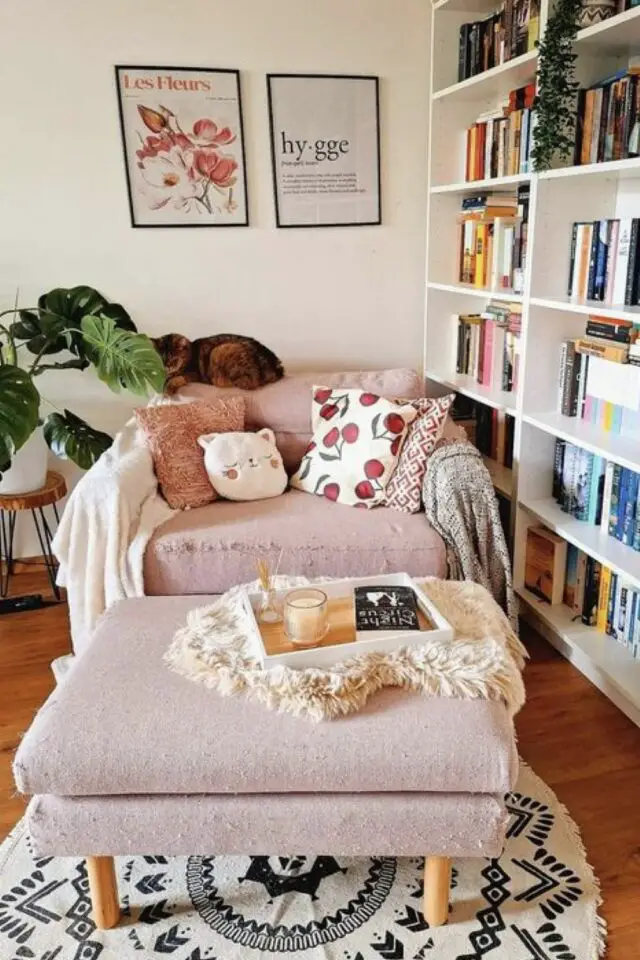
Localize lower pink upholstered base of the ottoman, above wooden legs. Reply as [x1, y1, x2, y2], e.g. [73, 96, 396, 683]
[27, 793, 509, 860]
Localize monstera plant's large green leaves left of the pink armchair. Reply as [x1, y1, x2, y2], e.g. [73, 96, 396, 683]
[0, 287, 165, 479]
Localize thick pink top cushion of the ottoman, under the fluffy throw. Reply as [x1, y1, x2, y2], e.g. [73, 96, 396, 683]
[14, 596, 517, 800]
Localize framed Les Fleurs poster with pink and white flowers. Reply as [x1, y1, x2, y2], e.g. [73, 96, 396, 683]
[115, 66, 249, 227]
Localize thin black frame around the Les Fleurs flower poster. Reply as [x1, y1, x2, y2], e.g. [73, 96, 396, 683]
[114, 64, 249, 229]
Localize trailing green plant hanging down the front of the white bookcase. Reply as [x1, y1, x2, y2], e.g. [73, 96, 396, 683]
[531, 0, 582, 171]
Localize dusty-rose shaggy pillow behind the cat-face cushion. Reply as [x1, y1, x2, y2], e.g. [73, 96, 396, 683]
[136, 396, 244, 510]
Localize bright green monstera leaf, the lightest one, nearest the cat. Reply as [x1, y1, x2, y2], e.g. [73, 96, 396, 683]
[82, 317, 165, 396]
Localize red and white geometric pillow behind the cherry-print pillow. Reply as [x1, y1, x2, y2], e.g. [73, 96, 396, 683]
[384, 393, 455, 513]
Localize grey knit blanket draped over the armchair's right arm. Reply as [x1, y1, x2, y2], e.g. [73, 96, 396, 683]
[422, 441, 518, 632]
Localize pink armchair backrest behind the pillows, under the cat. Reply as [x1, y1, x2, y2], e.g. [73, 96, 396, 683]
[180, 369, 424, 474]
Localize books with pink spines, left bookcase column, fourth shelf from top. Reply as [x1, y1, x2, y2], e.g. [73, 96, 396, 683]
[453, 303, 522, 391]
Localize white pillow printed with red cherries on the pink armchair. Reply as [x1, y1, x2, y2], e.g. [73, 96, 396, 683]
[291, 387, 418, 508]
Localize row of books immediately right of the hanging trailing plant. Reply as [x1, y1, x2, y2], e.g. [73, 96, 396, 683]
[574, 65, 640, 164]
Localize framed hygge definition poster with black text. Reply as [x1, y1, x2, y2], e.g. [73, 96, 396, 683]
[267, 73, 381, 227]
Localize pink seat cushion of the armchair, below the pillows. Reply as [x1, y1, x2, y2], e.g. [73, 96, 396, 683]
[144, 490, 447, 596]
